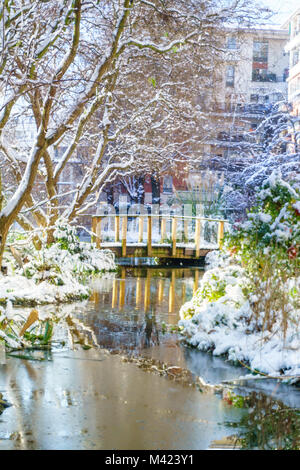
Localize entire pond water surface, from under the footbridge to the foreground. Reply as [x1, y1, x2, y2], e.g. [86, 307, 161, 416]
[0, 266, 300, 450]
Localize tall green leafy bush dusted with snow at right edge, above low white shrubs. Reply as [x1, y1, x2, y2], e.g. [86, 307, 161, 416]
[226, 172, 300, 334]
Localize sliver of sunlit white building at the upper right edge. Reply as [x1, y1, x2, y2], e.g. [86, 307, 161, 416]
[284, 8, 300, 116]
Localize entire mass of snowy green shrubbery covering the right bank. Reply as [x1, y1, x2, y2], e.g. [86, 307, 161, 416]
[180, 174, 300, 382]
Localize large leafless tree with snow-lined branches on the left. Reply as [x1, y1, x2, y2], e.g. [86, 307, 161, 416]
[0, 0, 270, 264]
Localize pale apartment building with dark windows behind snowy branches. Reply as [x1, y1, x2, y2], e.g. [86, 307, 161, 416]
[204, 28, 289, 162]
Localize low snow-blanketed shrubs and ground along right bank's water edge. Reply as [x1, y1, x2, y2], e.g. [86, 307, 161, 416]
[179, 252, 300, 381]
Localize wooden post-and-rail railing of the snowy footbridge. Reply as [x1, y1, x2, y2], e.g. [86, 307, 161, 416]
[92, 214, 228, 257]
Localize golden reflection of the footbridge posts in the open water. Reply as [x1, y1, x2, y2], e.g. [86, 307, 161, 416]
[82, 266, 203, 353]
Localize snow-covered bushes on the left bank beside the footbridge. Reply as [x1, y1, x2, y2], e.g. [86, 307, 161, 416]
[0, 220, 116, 305]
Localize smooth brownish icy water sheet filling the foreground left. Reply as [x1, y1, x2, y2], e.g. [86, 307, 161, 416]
[0, 350, 245, 450]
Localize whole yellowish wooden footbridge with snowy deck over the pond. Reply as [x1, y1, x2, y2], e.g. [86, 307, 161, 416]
[92, 214, 227, 259]
